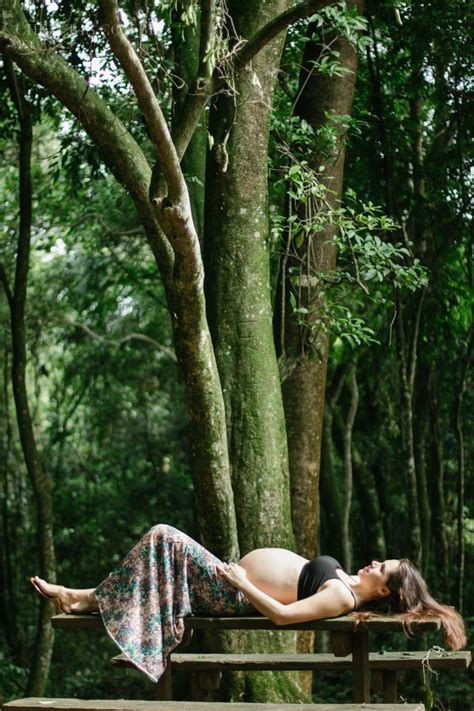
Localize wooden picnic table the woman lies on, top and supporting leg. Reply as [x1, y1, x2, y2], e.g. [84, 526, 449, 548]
[52, 614, 441, 703]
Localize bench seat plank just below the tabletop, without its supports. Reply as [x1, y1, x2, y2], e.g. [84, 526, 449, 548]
[111, 651, 471, 671]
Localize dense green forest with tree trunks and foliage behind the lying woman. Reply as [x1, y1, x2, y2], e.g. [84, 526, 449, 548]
[0, 0, 474, 710]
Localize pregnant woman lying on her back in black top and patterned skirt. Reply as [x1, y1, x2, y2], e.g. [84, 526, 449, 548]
[31, 524, 466, 681]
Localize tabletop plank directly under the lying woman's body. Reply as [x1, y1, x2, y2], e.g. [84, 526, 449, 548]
[51, 614, 440, 632]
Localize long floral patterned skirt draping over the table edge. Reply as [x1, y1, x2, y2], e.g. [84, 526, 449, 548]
[96, 524, 256, 681]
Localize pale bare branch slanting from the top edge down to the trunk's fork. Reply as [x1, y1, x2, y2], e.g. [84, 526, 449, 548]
[100, 0, 187, 204]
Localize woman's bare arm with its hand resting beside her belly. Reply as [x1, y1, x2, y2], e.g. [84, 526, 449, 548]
[218, 563, 352, 625]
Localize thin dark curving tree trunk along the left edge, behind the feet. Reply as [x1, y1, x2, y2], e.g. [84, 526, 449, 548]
[4, 58, 56, 696]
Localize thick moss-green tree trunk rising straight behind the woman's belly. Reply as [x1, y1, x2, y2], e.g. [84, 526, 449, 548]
[204, 0, 293, 553]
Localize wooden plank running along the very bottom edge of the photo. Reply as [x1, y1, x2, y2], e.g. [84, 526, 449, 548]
[3, 698, 425, 711]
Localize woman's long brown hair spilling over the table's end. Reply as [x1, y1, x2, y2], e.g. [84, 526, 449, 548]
[361, 558, 467, 649]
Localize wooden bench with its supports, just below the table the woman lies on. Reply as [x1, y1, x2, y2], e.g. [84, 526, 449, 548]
[111, 650, 471, 703]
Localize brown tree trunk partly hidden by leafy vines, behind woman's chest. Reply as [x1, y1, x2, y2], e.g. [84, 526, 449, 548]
[276, 2, 362, 558]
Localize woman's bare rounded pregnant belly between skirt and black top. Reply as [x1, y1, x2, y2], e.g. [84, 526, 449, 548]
[239, 548, 307, 605]
